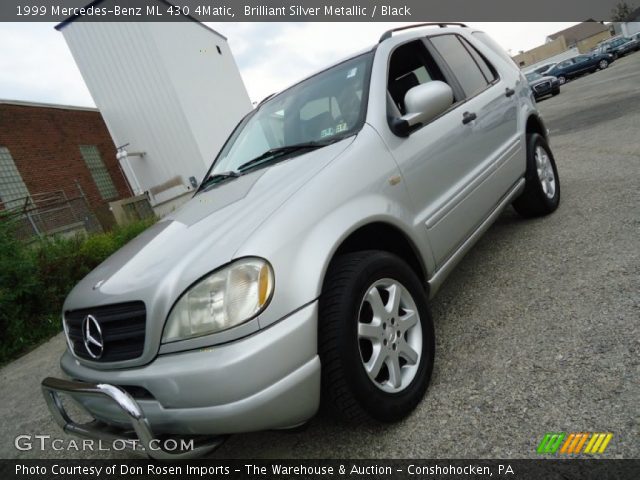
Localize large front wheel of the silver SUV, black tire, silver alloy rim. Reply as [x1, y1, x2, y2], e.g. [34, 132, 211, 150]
[318, 250, 435, 422]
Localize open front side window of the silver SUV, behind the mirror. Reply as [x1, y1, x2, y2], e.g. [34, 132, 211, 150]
[387, 40, 445, 117]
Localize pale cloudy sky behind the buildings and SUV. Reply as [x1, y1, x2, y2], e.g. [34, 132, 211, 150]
[0, 22, 575, 107]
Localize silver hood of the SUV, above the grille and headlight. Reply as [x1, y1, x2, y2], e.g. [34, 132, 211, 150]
[64, 137, 355, 310]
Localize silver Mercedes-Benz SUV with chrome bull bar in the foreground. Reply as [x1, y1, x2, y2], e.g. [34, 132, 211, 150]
[42, 24, 560, 458]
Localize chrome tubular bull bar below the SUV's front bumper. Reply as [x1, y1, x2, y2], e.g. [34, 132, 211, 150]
[42, 377, 226, 460]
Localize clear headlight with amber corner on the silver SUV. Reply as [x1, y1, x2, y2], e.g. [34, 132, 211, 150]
[162, 258, 273, 343]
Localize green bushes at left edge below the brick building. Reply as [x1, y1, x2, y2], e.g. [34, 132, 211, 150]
[0, 216, 155, 365]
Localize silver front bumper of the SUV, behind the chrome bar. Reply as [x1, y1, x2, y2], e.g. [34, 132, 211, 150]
[42, 302, 320, 458]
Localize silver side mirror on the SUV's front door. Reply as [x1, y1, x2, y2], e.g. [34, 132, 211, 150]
[392, 80, 453, 137]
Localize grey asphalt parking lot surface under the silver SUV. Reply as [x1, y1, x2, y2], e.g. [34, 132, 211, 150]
[0, 53, 640, 458]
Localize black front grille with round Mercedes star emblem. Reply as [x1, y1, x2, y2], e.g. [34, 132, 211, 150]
[64, 302, 147, 362]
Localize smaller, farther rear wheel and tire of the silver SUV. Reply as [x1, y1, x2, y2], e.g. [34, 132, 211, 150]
[513, 133, 560, 217]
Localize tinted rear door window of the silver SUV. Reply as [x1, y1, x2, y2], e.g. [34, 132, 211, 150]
[429, 34, 489, 97]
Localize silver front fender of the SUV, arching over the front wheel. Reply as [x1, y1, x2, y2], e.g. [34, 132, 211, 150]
[235, 126, 433, 327]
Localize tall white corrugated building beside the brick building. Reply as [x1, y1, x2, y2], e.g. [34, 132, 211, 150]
[62, 17, 251, 212]
